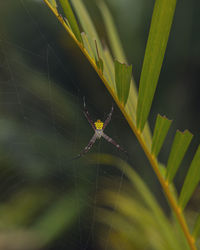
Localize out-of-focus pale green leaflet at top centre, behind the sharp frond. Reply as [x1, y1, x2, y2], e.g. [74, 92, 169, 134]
[98, 1, 127, 62]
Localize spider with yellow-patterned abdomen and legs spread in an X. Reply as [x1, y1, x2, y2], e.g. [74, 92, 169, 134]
[76, 98, 127, 158]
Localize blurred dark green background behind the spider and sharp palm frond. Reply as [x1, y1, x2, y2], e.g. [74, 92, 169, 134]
[0, 0, 200, 250]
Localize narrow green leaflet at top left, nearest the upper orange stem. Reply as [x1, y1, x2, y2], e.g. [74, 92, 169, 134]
[59, 0, 83, 44]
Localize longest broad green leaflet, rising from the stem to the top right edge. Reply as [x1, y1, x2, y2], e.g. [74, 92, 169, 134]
[137, 0, 176, 131]
